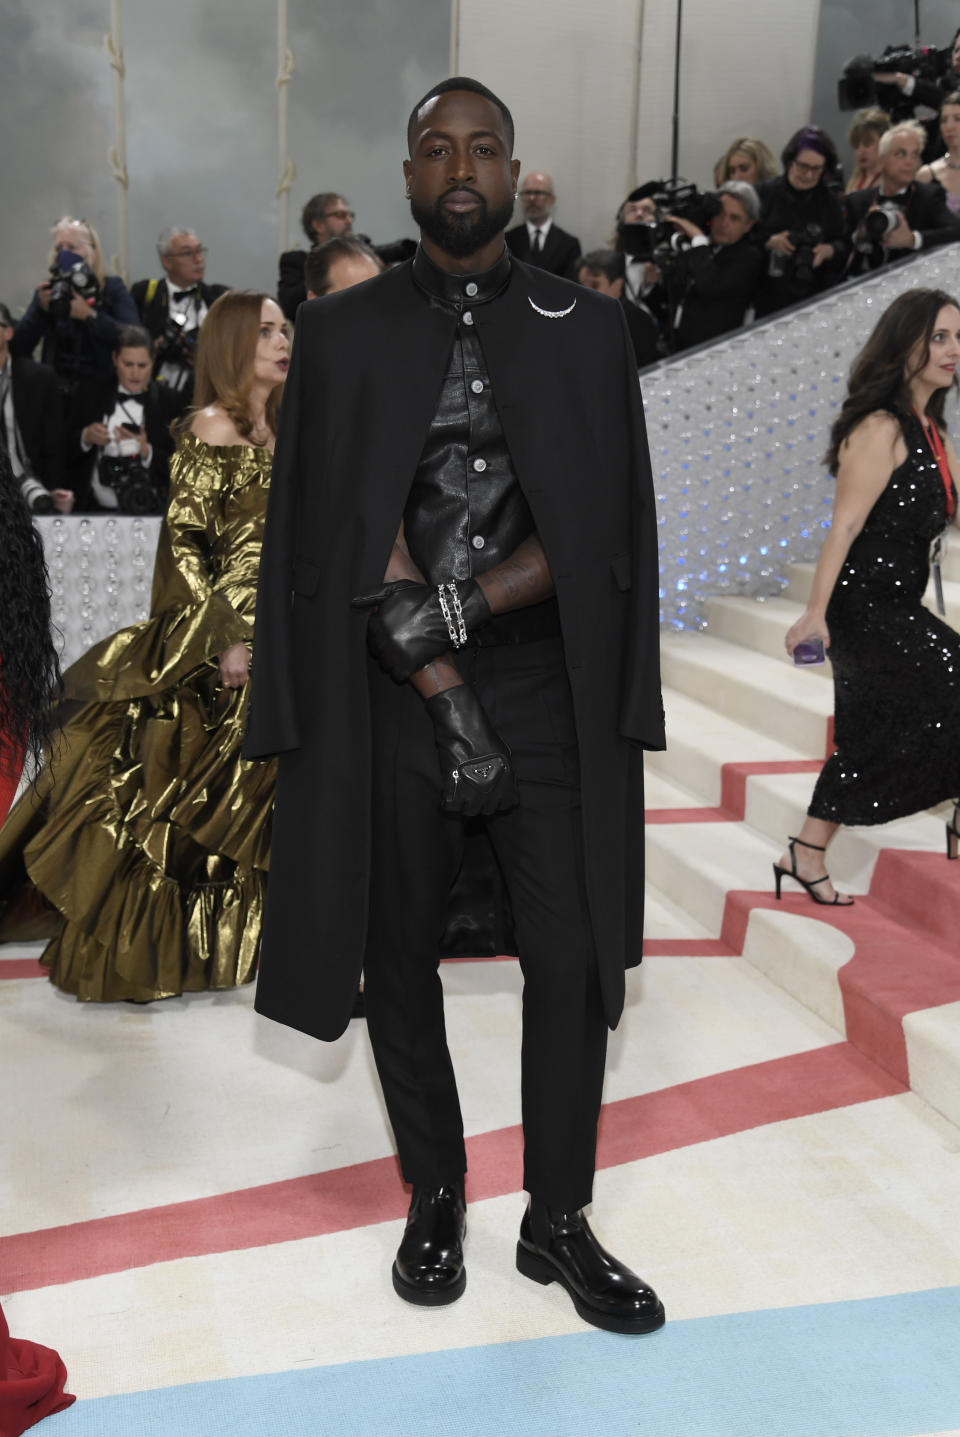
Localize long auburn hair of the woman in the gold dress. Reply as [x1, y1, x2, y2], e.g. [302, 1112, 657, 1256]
[177, 289, 283, 440]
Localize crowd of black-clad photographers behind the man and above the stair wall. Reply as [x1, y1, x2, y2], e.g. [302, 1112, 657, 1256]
[0, 30, 960, 514]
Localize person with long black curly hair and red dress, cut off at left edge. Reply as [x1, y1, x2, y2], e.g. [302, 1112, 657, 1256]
[0, 450, 75, 1437]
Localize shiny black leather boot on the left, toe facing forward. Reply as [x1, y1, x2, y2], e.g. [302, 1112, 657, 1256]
[392, 1186, 467, 1308]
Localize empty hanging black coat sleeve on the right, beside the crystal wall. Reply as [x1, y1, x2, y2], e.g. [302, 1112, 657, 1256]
[617, 306, 667, 749]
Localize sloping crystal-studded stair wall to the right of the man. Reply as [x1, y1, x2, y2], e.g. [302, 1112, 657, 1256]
[641, 244, 960, 629]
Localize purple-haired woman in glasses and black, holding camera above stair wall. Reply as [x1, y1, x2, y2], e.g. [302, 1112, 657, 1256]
[756, 125, 846, 319]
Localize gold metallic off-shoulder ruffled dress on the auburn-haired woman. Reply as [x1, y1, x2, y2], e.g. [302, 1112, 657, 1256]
[0, 434, 274, 1002]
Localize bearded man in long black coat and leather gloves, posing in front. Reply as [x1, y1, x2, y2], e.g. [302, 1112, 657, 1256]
[244, 78, 664, 1332]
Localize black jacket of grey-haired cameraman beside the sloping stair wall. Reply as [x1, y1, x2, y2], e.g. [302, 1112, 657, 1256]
[675, 236, 763, 349]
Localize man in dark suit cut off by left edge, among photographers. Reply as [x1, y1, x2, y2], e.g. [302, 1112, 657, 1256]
[0, 305, 73, 514]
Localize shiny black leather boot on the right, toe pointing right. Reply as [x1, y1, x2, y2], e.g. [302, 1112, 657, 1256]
[517, 1198, 667, 1334]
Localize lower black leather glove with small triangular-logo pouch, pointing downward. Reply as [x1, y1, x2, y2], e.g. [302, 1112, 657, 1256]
[427, 684, 519, 818]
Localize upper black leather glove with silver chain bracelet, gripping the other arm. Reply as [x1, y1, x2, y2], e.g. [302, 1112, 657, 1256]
[351, 579, 493, 684]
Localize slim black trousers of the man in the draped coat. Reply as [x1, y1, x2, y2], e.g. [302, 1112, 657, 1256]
[364, 639, 606, 1209]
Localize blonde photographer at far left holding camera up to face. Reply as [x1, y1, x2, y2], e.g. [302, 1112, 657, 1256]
[10, 216, 137, 397]
